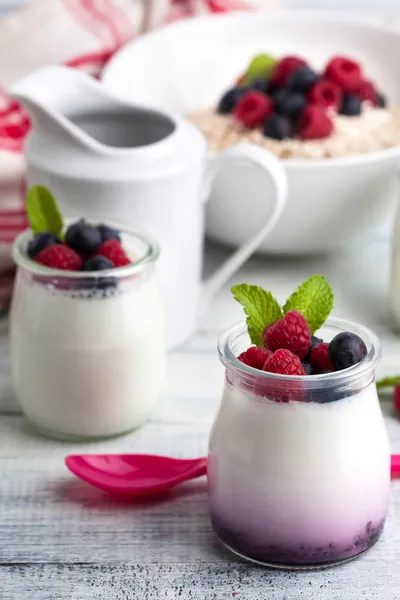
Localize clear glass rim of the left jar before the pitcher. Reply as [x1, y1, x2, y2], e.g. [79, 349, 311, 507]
[12, 220, 160, 280]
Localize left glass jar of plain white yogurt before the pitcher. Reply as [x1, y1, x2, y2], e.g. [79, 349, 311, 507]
[11, 225, 165, 440]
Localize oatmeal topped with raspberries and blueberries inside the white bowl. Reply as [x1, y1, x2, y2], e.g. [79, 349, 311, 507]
[189, 54, 400, 159]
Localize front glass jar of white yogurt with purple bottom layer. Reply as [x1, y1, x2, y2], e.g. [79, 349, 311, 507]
[208, 319, 390, 569]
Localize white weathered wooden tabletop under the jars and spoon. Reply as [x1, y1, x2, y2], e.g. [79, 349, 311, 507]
[0, 229, 400, 600]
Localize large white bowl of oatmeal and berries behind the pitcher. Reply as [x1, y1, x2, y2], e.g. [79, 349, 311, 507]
[103, 11, 400, 255]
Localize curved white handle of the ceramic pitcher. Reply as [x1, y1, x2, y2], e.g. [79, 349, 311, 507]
[200, 143, 288, 314]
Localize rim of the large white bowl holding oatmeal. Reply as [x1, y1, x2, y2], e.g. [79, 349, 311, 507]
[101, 9, 400, 170]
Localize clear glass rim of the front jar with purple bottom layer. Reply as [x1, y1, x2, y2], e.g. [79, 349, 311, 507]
[218, 317, 381, 387]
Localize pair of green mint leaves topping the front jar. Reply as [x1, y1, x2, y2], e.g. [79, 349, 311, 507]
[231, 275, 334, 346]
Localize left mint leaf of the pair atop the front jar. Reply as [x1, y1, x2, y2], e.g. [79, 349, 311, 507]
[231, 283, 283, 347]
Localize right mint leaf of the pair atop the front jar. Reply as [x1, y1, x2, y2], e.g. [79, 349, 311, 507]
[283, 275, 333, 333]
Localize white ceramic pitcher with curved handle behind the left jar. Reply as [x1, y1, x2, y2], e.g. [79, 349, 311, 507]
[11, 67, 287, 348]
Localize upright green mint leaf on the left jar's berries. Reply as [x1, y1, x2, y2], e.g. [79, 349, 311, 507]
[26, 185, 63, 236]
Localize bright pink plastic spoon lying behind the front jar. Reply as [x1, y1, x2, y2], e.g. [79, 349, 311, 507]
[65, 454, 400, 497]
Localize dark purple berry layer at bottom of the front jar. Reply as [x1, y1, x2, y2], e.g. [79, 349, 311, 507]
[211, 513, 385, 567]
